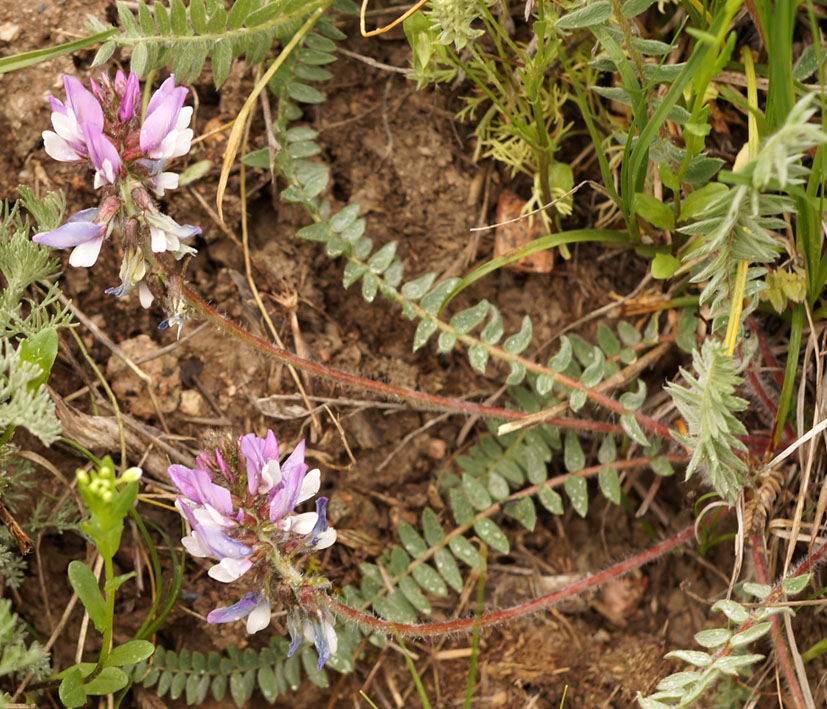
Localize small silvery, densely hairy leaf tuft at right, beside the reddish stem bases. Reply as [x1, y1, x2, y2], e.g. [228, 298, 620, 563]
[665, 338, 749, 504]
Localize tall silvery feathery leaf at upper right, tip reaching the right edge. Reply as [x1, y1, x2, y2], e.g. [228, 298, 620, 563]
[680, 94, 827, 330]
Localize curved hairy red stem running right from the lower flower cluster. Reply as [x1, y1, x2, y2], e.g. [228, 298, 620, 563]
[316, 525, 694, 637]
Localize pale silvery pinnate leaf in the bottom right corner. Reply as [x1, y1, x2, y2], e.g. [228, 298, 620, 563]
[637, 574, 810, 709]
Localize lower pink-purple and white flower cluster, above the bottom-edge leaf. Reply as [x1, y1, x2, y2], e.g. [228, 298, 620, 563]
[168, 431, 337, 668]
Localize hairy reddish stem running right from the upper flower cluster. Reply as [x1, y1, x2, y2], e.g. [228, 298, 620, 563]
[152, 254, 625, 434]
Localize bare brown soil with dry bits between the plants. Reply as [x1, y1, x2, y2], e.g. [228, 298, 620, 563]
[0, 0, 823, 709]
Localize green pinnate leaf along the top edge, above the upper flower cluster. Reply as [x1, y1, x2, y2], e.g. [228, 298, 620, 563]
[89, 0, 356, 88]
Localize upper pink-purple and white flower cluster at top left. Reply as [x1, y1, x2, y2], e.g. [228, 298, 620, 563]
[33, 70, 201, 308]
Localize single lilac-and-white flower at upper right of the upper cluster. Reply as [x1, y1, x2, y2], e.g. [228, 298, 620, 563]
[140, 74, 192, 161]
